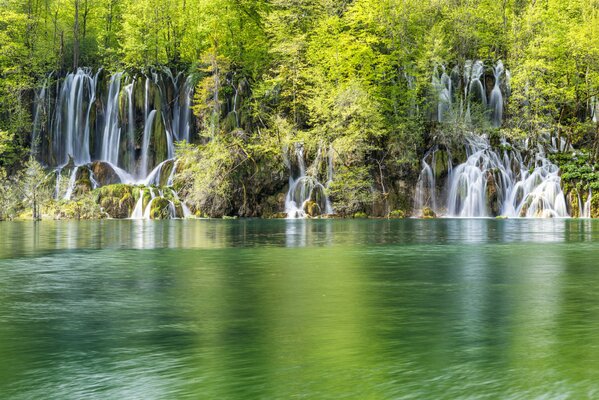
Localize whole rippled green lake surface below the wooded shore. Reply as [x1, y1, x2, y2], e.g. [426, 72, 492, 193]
[0, 219, 599, 399]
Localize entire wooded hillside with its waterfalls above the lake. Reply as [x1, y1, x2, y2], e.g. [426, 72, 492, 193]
[0, 0, 599, 220]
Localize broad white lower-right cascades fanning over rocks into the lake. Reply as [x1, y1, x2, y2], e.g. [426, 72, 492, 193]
[415, 136, 568, 218]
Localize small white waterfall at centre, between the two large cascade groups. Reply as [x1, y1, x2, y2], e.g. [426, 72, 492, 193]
[285, 144, 333, 218]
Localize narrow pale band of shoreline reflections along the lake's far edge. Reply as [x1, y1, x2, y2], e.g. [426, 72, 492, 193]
[0, 219, 599, 257]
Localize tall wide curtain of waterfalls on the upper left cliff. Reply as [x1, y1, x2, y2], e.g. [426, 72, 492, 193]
[31, 68, 194, 213]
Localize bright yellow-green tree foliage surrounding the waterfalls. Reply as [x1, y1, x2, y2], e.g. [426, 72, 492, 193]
[0, 0, 599, 219]
